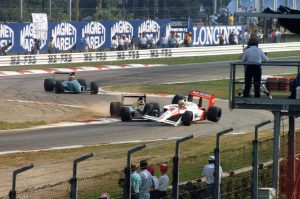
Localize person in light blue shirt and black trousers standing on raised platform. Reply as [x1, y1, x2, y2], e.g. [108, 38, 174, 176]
[241, 35, 268, 98]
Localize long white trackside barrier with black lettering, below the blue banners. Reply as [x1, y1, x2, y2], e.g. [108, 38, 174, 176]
[0, 42, 300, 66]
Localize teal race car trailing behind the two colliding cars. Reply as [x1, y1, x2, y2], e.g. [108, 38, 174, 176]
[44, 72, 99, 94]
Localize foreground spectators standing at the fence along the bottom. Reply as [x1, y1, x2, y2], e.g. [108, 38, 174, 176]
[112, 156, 223, 199]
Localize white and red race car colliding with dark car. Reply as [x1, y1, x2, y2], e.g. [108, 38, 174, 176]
[143, 91, 222, 126]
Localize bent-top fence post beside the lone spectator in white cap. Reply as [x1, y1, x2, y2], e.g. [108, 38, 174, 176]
[214, 128, 233, 199]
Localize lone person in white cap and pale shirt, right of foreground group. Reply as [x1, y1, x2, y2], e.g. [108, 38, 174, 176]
[202, 156, 223, 198]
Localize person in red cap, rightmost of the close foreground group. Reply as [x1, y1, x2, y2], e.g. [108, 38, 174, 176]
[158, 163, 169, 199]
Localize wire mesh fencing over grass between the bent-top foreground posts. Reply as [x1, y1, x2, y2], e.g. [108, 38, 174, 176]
[0, 126, 300, 199]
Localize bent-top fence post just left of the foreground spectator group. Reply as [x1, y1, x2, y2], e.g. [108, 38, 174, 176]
[124, 145, 146, 199]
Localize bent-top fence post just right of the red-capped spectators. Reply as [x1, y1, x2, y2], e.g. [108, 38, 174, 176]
[172, 135, 194, 199]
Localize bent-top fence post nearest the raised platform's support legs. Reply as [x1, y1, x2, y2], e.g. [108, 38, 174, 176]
[252, 120, 271, 199]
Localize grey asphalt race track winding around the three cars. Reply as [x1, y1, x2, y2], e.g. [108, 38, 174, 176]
[0, 58, 299, 152]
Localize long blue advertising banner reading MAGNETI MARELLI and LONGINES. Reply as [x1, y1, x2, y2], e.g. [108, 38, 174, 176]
[0, 19, 245, 54]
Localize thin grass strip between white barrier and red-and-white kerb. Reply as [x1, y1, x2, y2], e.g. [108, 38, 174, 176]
[0, 51, 300, 71]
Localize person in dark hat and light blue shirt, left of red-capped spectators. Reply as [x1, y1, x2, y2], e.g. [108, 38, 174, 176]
[139, 160, 153, 199]
